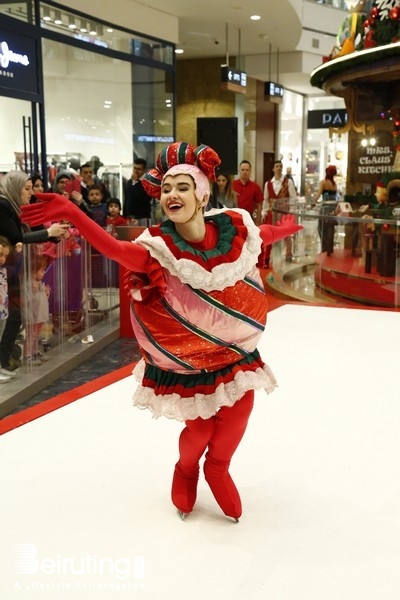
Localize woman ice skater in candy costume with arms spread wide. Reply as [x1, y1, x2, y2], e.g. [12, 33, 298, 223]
[23, 142, 301, 521]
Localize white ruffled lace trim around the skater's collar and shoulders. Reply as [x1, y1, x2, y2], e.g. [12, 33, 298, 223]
[136, 209, 261, 292]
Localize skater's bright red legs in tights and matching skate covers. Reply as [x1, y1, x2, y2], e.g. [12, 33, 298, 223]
[172, 390, 254, 518]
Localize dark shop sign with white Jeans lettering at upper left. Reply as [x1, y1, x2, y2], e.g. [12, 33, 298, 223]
[0, 30, 39, 95]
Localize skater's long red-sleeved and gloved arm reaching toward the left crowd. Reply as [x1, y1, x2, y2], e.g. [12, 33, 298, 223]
[21, 194, 151, 273]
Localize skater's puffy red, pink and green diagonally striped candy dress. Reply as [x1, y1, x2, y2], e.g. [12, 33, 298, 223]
[129, 209, 276, 421]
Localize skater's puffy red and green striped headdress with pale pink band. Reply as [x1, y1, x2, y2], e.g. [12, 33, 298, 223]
[142, 142, 221, 200]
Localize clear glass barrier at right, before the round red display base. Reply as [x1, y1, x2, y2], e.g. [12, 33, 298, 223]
[267, 199, 400, 308]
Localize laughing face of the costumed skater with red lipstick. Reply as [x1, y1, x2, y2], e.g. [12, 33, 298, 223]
[160, 175, 205, 224]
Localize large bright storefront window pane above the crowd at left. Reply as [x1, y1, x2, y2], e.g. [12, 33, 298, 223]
[43, 40, 132, 176]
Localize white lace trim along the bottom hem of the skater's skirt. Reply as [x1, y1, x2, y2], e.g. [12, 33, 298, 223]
[133, 360, 277, 421]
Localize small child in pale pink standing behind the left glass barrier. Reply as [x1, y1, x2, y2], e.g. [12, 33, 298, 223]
[24, 255, 50, 367]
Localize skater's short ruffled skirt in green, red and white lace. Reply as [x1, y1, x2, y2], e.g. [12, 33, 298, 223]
[133, 350, 277, 421]
